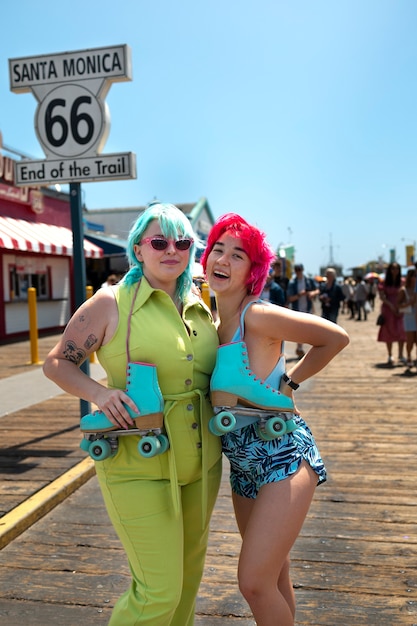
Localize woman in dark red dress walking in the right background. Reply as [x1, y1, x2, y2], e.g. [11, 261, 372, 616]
[377, 263, 407, 366]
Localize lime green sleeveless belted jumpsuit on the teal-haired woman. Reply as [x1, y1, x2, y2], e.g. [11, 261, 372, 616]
[96, 278, 221, 626]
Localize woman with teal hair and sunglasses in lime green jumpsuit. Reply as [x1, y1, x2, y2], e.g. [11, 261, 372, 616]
[44, 203, 221, 626]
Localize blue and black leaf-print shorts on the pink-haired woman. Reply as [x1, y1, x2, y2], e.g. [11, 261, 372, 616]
[222, 416, 326, 498]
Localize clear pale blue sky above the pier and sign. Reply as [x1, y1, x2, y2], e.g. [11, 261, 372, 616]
[0, 0, 417, 274]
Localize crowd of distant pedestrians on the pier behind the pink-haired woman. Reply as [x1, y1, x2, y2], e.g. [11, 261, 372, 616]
[263, 259, 417, 369]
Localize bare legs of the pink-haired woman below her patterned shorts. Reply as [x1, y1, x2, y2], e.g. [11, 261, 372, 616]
[233, 462, 317, 626]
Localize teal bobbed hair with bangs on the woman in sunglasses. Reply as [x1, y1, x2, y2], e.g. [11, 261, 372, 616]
[122, 202, 202, 302]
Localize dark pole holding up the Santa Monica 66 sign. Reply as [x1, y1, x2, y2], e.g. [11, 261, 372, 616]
[70, 183, 91, 417]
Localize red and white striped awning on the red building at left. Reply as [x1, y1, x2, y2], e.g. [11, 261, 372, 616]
[0, 216, 104, 259]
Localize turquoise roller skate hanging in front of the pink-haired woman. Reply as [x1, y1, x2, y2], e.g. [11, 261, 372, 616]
[209, 341, 298, 441]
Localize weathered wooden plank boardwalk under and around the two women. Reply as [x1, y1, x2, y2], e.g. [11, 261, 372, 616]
[0, 313, 417, 626]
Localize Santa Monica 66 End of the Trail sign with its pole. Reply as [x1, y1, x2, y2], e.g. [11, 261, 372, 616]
[9, 45, 136, 416]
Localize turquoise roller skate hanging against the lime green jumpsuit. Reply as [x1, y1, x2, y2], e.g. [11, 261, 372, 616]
[80, 363, 169, 461]
